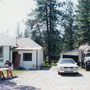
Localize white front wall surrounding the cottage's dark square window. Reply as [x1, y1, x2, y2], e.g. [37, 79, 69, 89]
[18, 51, 36, 69]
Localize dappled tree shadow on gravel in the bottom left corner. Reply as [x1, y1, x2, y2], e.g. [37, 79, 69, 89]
[0, 80, 41, 90]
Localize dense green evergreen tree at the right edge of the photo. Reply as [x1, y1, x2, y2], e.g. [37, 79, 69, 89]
[76, 0, 90, 45]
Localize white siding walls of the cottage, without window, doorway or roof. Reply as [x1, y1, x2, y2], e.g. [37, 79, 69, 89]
[0, 46, 43, 69]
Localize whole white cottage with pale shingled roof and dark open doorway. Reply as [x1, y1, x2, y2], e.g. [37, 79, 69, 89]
[0, 34, 43, 69]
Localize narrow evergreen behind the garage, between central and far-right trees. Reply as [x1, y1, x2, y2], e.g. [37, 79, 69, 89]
[61, 0, 75, 51]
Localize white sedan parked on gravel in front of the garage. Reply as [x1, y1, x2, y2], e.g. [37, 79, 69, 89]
[57, 58, 78, 74]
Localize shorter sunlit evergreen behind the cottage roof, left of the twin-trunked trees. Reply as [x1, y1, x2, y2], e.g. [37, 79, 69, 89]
[24, 10, 44, 46]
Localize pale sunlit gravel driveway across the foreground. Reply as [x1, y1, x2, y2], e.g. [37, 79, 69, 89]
[0, 67, 90, 90]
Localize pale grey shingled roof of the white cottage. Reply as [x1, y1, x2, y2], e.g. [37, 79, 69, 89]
[0, 34, 42, 50]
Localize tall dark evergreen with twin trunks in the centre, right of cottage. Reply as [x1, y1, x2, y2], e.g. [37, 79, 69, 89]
[25, 0, 61, 64]
